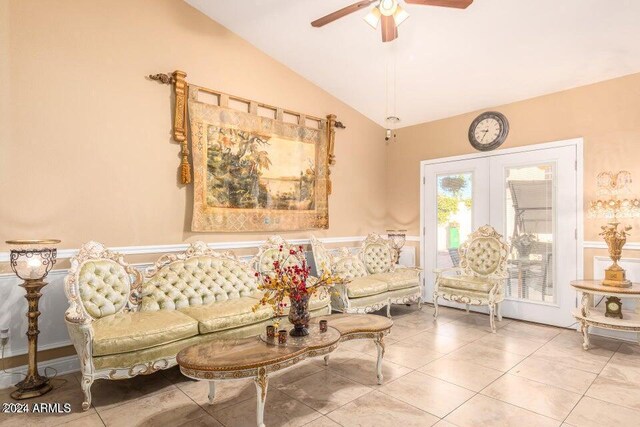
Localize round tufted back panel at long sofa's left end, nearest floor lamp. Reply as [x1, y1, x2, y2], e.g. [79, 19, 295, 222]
[78, 259, 131, 319]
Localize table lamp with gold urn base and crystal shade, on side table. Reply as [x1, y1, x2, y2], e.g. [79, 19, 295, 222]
[587, 171, 640, 288]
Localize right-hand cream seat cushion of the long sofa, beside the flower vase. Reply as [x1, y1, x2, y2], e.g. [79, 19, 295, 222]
[178, 297, 273, 334]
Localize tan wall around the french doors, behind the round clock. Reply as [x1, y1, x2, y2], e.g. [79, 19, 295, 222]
[387, 74, 640, 251]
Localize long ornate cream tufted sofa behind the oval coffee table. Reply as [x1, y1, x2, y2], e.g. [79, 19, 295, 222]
[65, 242, 331, 410]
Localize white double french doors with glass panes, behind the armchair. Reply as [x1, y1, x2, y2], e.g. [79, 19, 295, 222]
[422, 141, 582, 326]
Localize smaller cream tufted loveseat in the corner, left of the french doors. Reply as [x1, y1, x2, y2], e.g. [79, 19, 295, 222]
[311, 233, 423, 317]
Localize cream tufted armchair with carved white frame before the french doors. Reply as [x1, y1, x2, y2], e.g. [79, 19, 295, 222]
[433, 225, 509, 332]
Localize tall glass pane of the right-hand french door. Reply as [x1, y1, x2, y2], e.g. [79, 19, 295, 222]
[504, 163, 556, 303]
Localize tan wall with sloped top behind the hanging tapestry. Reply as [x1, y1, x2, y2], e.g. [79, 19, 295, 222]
[0, 0, 386, 251]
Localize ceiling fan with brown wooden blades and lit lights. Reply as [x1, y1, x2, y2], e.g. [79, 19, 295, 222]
[311, 0, 473, 42]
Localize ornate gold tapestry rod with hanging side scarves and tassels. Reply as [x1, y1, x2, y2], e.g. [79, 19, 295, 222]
[148, 70, 346, 187]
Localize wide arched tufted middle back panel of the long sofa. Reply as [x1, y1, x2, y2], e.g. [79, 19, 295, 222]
[141, 254, 258, 311]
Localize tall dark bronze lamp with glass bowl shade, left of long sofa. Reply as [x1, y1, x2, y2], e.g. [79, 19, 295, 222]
[7, 239, 60, 400]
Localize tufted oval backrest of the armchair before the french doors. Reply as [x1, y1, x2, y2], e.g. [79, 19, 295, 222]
[460, 225, 508, 277]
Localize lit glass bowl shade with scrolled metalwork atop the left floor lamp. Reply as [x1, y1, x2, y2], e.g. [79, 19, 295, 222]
[6, 239, 60, 280]
